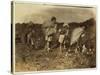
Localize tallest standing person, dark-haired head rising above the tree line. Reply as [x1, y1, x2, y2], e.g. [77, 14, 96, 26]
[43, 17, 56, 52]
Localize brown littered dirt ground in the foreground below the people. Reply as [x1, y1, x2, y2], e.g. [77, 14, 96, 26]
[15, 44, 96, 72]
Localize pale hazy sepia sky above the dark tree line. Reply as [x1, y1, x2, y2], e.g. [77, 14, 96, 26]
[15, 2, 96, 24]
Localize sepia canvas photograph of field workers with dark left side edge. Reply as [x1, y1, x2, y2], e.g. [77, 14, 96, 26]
[11, 1, 96, 72]
